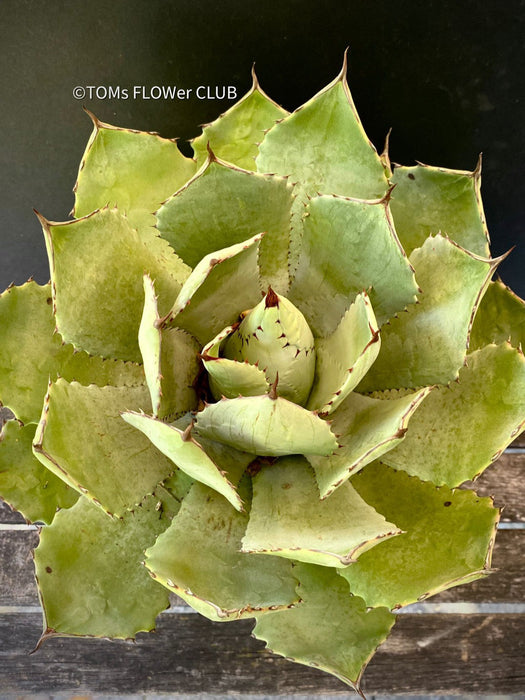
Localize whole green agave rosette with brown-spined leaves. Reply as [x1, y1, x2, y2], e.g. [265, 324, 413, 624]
[0, 56, 525, 691]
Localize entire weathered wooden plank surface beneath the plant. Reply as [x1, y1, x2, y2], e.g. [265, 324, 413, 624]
[0, 441, 525, 698]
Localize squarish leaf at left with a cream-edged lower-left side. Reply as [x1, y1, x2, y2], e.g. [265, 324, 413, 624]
[34, 379, 174, 516]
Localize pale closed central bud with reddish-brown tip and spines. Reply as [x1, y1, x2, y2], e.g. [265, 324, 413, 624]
[224, 287, 315, 405]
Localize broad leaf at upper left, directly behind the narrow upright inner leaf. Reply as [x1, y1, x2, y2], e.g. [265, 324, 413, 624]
[41, 209, 189, 362]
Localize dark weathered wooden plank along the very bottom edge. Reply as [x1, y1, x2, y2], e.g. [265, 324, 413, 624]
[0, 614, 525, 696]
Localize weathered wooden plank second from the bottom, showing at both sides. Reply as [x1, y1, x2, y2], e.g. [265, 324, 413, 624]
[0, 530, 525, 605]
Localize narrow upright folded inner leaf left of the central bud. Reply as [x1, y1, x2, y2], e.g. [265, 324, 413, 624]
[139, 275, 199, 418]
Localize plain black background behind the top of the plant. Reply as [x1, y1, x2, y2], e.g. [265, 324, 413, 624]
[0, 0, 525, 296]
